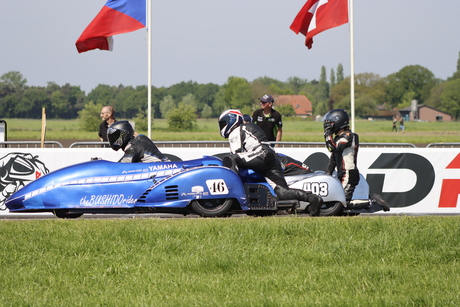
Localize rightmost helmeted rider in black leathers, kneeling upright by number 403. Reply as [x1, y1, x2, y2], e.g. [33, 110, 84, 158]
[323, 109, 390, 211]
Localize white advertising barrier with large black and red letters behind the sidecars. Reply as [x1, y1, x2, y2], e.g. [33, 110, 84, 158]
[0, 147, 460, 215]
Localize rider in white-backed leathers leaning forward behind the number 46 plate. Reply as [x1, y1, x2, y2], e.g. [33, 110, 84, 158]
[219, 110, 323, 216]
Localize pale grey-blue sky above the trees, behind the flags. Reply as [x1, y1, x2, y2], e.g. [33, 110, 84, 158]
[0, 0, 460, 94]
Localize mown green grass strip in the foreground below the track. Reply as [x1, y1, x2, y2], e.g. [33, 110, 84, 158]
[0, 216, 460, 306]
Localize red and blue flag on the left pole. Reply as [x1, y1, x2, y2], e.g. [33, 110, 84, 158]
[75, 0, 146, 53]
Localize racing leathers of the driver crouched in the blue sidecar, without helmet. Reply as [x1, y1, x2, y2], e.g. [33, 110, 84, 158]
[118, 134, 169, 163]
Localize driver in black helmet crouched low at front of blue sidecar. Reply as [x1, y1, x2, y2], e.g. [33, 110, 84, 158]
[107, 121, 169, 163]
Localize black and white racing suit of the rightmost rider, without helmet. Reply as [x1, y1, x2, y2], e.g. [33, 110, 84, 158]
[324, 129, 359, 202]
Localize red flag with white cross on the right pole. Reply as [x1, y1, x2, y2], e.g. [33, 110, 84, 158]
[290, 0, 348, 49]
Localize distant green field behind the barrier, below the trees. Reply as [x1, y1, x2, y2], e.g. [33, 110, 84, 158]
[6, 118, 460, 144]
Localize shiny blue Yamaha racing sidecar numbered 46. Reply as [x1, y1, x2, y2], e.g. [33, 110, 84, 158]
[5, 157, 292, 218]
